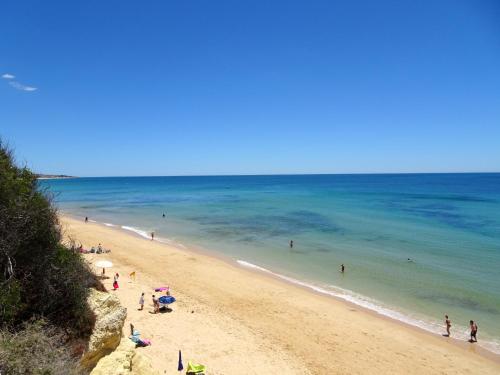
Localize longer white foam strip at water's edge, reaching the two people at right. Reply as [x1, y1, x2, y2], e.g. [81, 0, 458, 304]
[236, 260, 500, 354]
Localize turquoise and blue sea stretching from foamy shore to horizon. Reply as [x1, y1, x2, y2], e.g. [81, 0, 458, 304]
[41, 174, 500, 353]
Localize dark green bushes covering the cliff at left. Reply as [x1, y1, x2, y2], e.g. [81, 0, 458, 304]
[0, 141, 102, 374]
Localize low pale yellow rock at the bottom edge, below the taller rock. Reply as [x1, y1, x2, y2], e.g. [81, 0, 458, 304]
[90, 339, 159, 375]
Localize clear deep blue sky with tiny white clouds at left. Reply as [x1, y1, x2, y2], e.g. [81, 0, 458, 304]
[0, 0, 500, 176]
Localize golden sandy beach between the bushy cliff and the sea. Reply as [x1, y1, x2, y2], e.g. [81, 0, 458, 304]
[61, 216, 500, 374]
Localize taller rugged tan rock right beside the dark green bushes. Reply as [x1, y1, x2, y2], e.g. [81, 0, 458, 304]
[81, 289, 127, 369]
